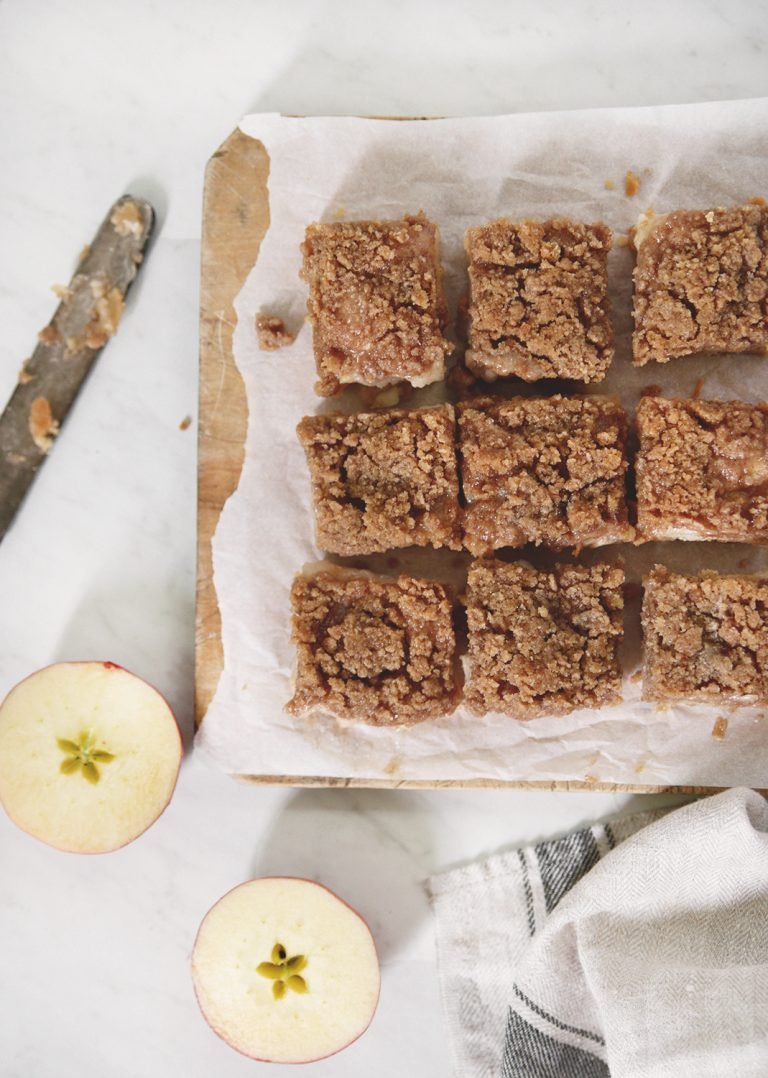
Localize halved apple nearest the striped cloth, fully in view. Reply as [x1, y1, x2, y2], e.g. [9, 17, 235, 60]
[192, 876, 381, 1063]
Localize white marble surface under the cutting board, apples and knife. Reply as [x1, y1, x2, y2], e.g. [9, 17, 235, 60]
[0, 0, 768, 1078]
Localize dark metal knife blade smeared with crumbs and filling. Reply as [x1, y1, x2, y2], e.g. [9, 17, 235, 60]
[0, 195, 154, 541]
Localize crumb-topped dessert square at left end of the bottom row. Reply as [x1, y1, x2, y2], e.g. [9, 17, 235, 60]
[286, 566, 460, 727]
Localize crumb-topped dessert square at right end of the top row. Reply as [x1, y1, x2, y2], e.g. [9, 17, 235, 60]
[632, 205, 768, 367]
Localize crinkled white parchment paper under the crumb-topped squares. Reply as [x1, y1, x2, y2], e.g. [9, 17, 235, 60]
[197, 99, 768, 786]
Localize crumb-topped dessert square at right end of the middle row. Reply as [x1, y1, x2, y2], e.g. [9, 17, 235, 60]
[635, 397, 768, 543]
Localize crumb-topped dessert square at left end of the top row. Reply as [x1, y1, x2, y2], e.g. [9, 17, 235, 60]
[301, 213, 452, 397]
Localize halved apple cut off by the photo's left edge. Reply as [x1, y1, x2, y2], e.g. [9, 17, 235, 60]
[0, 662, 182, 854]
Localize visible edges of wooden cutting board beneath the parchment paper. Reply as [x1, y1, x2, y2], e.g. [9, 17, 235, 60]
[195, 129, 717, 793]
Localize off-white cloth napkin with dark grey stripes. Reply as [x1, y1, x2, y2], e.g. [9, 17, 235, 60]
[430, 789, 768, 1078]
